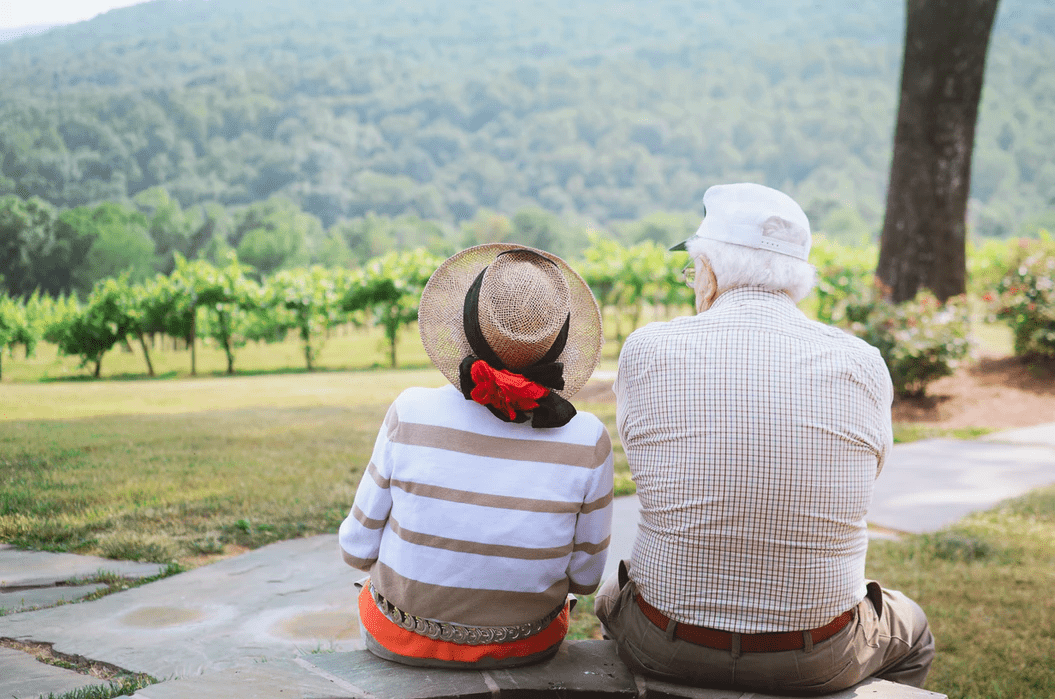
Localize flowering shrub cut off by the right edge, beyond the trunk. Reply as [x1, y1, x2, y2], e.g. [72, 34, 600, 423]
[983, 231, 1055, 356]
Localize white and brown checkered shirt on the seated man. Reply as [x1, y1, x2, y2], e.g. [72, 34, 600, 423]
[615, 288, 893, 634]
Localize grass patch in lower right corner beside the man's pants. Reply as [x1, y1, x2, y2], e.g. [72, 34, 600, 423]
[868, 487, 1055, 699]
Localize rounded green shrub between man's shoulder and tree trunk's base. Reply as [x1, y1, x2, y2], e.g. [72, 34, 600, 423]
[846, 290, 971, 396]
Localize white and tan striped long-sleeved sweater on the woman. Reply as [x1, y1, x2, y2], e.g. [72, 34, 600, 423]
[340, 385, 612, 626]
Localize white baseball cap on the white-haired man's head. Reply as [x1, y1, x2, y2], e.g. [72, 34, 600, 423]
[670, 182, 811, 260]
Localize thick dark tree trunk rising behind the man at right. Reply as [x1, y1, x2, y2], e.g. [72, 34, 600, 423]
[876, 0, 999, 303]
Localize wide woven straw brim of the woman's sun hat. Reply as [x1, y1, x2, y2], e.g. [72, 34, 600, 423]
[418, 242, 605, 399]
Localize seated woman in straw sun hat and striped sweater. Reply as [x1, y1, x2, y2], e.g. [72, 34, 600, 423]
[340, 244, 612, 667]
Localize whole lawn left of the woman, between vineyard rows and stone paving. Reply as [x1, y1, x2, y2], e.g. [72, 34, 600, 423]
[0, 370, 443, 563]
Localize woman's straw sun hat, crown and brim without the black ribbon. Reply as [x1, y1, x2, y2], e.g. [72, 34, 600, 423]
[418, 242, 603, 411]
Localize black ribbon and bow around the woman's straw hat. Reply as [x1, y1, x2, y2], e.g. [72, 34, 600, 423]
[458, 266, 575, 428]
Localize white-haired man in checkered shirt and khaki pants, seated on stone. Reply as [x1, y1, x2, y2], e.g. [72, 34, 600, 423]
[595, 183, 934, 694]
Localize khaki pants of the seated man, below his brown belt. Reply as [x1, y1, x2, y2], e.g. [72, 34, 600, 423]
[594, 570, 934, 695]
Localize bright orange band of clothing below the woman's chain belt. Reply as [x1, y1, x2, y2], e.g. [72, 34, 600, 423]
[359, 586, 569, 663]
